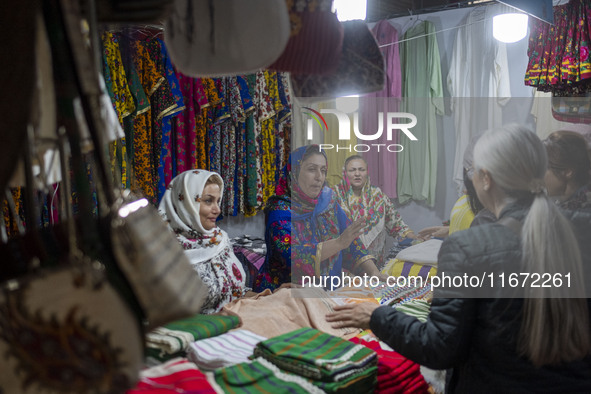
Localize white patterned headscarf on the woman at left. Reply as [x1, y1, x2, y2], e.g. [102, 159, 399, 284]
[158, 170, 229, 260]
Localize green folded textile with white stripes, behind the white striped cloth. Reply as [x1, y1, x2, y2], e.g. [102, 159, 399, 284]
[146, 314, 240, 361]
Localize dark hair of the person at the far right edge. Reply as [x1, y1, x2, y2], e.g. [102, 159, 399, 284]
[544, 130, 591, 184]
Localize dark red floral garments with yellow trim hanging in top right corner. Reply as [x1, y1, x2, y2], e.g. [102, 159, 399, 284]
[525, 0, 591, 95]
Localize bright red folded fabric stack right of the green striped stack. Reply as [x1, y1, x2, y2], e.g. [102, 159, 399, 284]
[350, 338, 429, 393]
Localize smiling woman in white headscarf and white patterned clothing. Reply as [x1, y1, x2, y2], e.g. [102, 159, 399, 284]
[158, 170, 246, 313]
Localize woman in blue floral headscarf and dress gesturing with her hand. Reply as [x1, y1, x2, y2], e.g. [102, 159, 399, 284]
[255, 145, 381, 291]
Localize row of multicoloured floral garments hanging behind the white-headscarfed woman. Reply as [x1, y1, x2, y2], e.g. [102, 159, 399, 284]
[93, 28, 291, 216]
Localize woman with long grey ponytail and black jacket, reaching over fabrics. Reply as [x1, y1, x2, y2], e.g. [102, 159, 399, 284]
[327, 125, 591, 393]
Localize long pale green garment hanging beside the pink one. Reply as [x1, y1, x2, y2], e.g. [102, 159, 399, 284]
[397, 21, 443, 207]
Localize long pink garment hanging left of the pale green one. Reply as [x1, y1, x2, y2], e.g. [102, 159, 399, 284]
[359, 20, 402, 198]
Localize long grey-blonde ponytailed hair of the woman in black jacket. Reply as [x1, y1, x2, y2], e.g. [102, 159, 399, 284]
[474, 124, 591, 366]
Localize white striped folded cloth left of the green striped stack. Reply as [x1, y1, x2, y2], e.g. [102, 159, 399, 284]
[187, 330, 267, 370]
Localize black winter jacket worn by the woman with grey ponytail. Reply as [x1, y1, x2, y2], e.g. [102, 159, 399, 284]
[370, 204, 591, 393]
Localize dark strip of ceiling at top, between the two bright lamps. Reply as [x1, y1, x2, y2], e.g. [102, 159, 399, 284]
[366, 0, 492, 22]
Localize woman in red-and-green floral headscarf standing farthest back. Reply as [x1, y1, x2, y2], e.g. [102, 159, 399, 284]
[334, 155, 416, 267]
